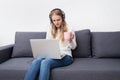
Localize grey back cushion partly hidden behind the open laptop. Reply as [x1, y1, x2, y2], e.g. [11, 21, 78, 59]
[12, 32, 46, 57]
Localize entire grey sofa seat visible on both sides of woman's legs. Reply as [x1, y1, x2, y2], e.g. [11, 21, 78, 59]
[0, 58, 120, 80]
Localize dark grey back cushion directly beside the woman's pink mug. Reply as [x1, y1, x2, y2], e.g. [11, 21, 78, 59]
[72, 29, 91, 58]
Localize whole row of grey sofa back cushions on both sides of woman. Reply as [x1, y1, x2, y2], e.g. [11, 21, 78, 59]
[12, 29, 120, 58]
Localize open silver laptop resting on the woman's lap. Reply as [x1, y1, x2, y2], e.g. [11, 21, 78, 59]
[30, 39, 61, 59]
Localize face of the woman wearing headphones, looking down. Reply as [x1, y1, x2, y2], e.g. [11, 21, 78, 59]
[51, 14, 62, 28]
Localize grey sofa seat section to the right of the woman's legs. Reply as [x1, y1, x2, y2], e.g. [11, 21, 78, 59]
[51, 58, 120, 80]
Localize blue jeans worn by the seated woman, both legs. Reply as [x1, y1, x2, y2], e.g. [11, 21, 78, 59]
[24, 55, 73, 80]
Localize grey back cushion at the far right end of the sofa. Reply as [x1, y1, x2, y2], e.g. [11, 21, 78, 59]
[92, 32, 120, 58]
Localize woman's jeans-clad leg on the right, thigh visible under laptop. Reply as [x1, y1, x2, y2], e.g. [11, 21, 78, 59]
[39, 55, 73, 80]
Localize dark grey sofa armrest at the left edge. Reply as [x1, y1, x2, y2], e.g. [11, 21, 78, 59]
[0, 44, 14, 64]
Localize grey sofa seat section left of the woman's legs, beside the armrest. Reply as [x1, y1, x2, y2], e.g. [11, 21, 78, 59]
[0, 58, 33, 80]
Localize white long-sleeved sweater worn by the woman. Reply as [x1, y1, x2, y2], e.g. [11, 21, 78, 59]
[46, 29, 77, 57]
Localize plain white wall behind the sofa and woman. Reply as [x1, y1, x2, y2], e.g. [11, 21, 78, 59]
[0, 0, 120, 46]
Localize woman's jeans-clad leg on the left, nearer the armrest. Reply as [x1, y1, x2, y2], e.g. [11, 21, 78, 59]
[24, 57, 44, 80]
